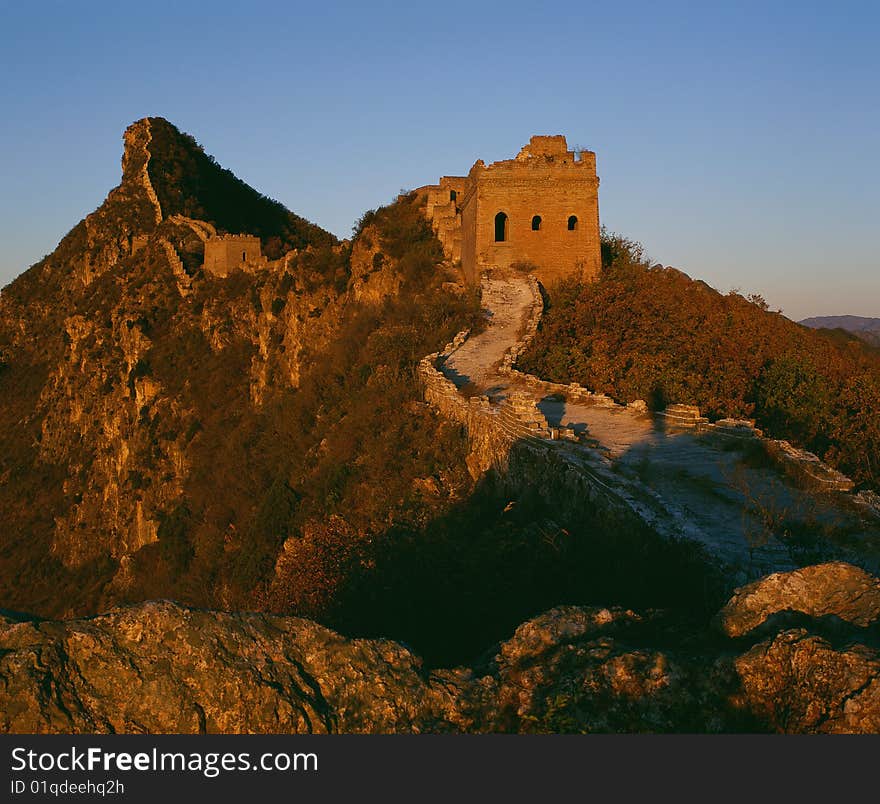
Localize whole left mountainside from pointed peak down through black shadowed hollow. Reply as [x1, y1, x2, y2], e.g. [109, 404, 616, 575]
[0, 119, 729, 662]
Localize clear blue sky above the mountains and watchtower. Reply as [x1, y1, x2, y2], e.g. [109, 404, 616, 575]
[0, 0, 880, 319]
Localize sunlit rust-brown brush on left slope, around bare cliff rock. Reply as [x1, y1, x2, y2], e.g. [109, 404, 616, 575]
[0, 192, 478, 614]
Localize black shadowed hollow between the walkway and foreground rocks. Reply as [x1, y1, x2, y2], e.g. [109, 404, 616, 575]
[330, 450, 730, 667]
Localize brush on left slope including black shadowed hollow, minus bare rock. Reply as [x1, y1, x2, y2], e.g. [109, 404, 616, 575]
[0, 188, 720, 664]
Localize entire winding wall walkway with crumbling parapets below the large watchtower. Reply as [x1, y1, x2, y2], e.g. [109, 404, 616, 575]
[420, 274, 880, 579]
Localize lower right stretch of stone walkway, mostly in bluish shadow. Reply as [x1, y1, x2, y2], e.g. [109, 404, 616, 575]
[537, 394, 880, 577]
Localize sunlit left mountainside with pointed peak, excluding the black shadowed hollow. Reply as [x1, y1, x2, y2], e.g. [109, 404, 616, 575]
[0, 119, 474, 628]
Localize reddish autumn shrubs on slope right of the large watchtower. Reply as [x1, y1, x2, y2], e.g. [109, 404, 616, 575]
[520, 229, 880, 486]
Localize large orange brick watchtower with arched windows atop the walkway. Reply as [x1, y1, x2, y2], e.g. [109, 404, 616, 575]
[423, 136, 602, 285]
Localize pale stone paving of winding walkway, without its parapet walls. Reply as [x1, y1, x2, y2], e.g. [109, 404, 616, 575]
[441, 274, 880, 580]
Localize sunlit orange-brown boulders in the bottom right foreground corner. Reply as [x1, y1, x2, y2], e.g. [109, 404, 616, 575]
[717, 562, 880, 733]
